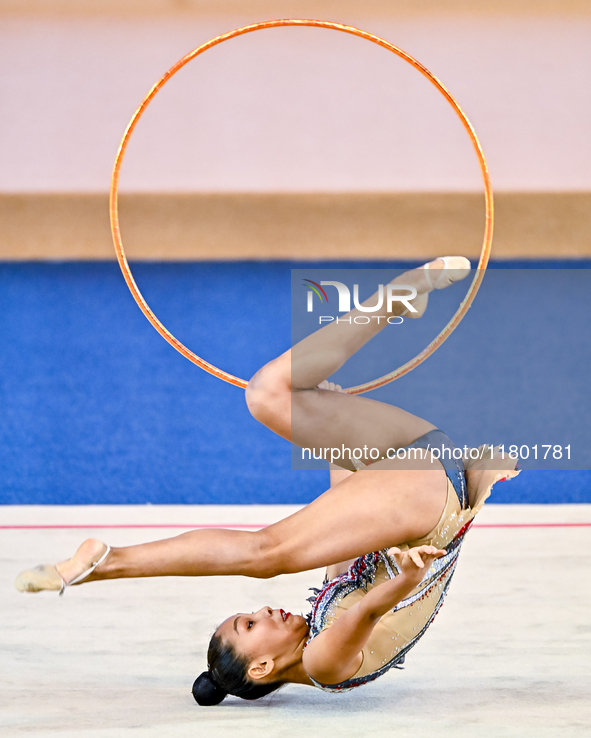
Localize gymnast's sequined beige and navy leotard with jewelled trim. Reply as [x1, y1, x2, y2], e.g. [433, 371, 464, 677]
[306, 431, 518, 692]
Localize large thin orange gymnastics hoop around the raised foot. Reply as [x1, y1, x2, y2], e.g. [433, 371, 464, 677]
[110, 18, 494, 395]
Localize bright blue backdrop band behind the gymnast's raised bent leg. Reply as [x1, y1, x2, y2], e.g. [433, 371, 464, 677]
[0, 262, 591, 504]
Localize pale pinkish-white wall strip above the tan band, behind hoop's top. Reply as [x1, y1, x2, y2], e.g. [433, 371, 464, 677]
[0, 7, 591, 192]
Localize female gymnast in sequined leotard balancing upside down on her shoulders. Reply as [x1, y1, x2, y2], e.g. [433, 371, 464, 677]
[16, 257, 517, 705]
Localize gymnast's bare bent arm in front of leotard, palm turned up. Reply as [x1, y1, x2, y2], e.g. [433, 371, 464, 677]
[303, 546, 445, 684]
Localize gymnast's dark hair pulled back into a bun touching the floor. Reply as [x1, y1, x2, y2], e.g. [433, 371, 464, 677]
[193, 634, 282, 706]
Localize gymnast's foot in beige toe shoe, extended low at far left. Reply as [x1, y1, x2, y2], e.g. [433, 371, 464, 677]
[14, 538, 111, 594]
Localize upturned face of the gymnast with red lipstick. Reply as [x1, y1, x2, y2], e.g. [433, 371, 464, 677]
[217, 607, 308, 677]
